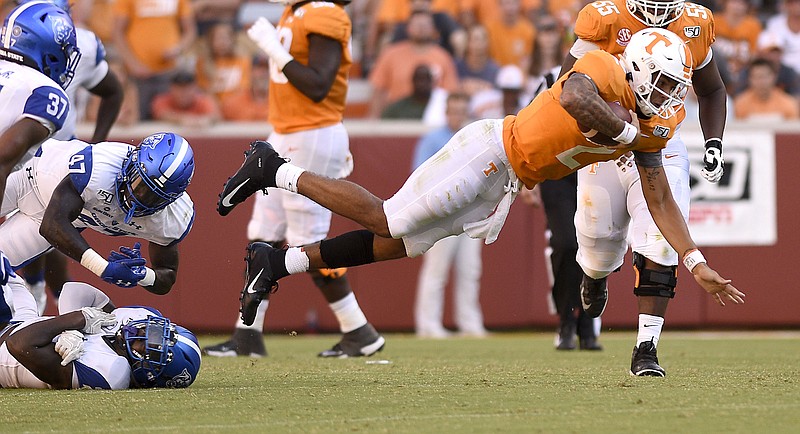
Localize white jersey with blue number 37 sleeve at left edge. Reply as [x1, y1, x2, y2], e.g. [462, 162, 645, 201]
[0, 60, 70, 168]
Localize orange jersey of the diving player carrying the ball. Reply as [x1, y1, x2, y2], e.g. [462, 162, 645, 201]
[503, 50, 677, 188]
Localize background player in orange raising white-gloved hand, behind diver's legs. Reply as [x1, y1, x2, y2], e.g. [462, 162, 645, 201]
[204, 0, 384, 358]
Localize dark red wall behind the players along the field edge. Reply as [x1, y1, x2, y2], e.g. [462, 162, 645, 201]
[61, 125, 800, 332]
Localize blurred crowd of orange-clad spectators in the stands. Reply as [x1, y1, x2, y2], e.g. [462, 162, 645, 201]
[73, 0, 800, 127]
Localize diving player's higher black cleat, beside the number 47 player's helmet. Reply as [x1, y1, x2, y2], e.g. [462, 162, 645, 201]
[217, 140, 286, 216]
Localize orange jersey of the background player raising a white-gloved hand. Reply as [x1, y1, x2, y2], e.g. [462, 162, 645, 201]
[269, 1, 352, 134]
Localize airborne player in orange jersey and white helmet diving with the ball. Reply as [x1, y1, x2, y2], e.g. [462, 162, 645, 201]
[217, 29, 744, 362]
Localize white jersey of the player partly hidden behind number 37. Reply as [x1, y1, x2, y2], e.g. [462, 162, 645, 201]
[53, 27, 108, 140]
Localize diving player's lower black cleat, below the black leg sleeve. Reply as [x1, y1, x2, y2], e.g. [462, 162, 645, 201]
[239, 241, 278, 326]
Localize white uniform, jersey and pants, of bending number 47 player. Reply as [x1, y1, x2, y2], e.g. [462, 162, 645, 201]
[0, 139, 195, 268]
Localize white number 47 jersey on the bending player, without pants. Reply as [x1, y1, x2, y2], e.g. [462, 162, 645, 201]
[33, 139, 194, 246]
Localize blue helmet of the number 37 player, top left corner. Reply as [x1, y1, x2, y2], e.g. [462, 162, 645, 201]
[0, 2, 81, 89]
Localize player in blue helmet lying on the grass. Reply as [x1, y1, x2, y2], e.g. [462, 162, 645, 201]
[0, 278, 201, 389]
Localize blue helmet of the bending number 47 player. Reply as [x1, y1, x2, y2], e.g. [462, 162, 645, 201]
[117, 133, 194, 223]
